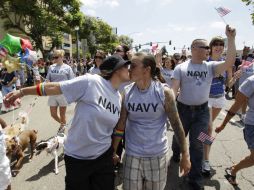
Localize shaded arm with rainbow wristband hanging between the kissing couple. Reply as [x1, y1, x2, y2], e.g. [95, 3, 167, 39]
[112, 94, 128, 164]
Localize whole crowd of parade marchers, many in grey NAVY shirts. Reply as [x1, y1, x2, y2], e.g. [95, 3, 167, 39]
[0, 26, 254, 190]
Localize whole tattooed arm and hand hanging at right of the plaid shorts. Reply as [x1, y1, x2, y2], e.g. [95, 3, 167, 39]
[164, 87, 191, 175]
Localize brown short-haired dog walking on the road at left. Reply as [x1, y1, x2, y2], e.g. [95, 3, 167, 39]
[6, 130, 37, 176]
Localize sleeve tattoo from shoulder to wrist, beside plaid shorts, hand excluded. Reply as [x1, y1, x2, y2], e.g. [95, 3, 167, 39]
[165, 88, 187, 153]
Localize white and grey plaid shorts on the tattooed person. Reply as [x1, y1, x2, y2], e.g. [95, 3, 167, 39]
[123, 153, 169, 190]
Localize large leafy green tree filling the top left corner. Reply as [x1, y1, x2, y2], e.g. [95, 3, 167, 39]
[0, 0, 83, 56]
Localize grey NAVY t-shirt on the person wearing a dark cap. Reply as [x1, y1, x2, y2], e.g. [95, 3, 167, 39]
[60, 74, 121, 160]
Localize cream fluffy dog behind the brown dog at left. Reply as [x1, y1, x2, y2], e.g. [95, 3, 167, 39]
[4, 112, 29, 139]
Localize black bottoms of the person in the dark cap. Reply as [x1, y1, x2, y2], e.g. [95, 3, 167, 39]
[64, 148, 114, 190]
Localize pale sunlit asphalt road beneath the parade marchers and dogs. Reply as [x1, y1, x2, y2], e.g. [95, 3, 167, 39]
[0, 96, 254, 190]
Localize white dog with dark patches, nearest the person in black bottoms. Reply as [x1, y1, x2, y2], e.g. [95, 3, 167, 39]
[35, 133, 66, 175]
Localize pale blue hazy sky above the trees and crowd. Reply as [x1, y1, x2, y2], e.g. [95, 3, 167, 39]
[81, 0, 254, 53]
